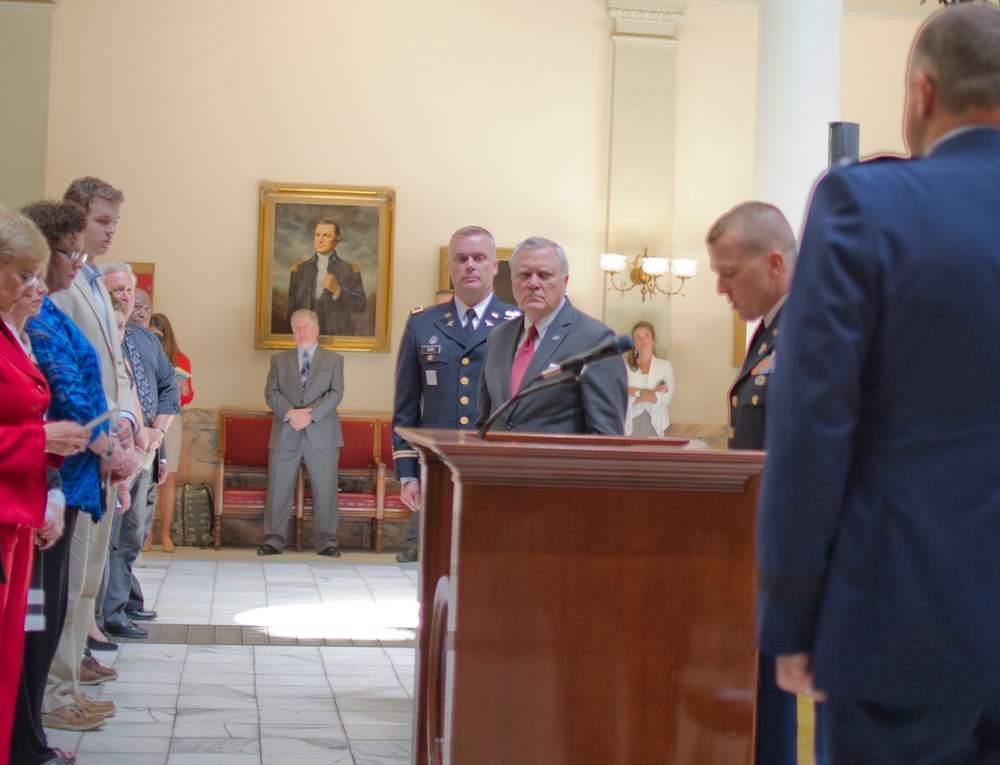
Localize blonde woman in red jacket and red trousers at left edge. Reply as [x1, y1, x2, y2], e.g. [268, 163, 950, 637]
[0, 208, 89, 758]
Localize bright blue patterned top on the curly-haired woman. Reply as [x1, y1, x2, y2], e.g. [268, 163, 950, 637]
[25, 296, 108, 521]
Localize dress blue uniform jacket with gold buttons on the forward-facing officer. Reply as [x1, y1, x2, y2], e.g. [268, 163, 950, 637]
[392, 295, 521, 478]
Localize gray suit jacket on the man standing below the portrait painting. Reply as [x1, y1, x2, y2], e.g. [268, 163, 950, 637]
[264, 346, 344, 450]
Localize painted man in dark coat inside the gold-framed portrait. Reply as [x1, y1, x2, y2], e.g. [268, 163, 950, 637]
[288, 220, 368, 335]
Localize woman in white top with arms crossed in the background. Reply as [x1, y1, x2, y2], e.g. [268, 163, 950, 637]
[625, 321, 674, 438]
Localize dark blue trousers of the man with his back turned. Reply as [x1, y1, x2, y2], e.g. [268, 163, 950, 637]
[824, 696, 1000, 765]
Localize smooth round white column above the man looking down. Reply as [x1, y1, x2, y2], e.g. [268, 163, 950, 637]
[754, 0, 844, 234]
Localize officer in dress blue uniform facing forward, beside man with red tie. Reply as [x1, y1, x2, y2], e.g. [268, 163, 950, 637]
[392, 226, 521, 563]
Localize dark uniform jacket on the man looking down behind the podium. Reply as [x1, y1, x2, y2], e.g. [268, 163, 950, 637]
[729, 310, 781, 449]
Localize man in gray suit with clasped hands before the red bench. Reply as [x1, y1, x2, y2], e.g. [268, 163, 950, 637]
[257, 309, 344, 558]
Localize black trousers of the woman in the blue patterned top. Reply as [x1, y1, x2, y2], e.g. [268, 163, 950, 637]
[10, 506, 79, 765]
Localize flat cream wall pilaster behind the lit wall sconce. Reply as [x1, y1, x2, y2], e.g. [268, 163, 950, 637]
[594, 0, 687, 341]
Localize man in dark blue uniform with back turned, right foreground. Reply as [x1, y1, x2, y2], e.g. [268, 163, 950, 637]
[757, 4, 1000, 765]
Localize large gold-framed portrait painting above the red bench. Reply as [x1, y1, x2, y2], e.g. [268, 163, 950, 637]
[254, 181, 396, 353]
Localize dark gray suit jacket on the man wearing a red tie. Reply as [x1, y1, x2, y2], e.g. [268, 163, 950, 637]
[477, 300, 628, 436]
